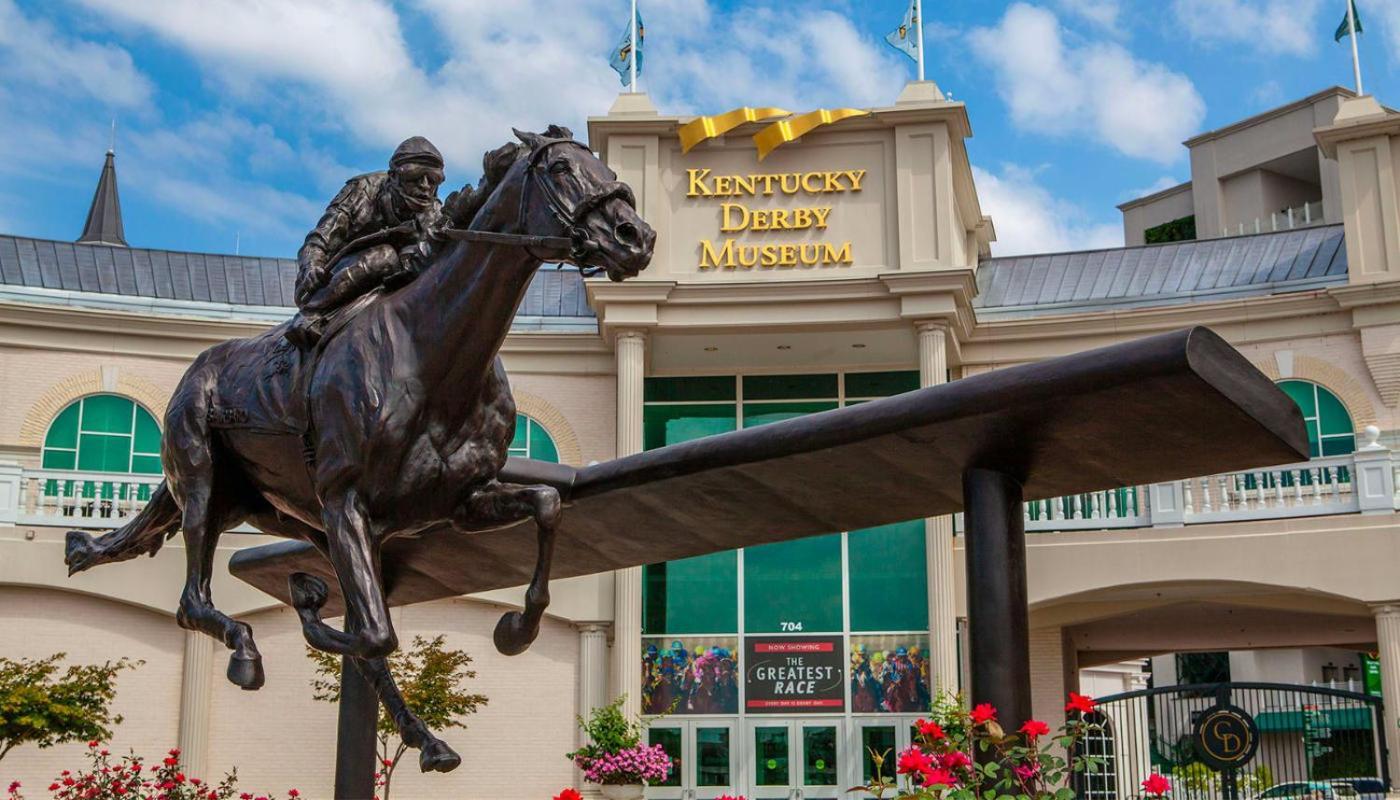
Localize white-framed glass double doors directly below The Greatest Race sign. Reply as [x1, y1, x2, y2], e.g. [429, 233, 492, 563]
[745, 719, 846, 800]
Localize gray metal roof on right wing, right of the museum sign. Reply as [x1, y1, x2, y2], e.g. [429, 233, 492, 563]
[973, 224, 1347, 314]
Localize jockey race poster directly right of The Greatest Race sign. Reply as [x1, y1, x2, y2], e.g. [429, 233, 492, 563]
[850, 633, 932, 715]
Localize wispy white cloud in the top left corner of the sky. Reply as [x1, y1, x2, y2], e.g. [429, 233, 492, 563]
[0, 0, 153, 108]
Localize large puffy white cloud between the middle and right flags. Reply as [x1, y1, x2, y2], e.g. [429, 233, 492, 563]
[970, 3, 1205, 164]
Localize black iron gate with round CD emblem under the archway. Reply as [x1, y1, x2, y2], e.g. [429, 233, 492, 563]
[1077, 682, 1390, 800]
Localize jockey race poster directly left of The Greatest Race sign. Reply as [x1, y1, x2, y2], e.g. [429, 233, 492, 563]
[641, 636, 739, 715]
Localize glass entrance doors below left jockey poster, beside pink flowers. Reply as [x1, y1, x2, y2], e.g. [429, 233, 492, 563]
[647, 719, 742, 800]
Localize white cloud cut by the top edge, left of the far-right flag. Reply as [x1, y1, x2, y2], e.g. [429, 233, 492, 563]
[1172, 0, 1321, 56]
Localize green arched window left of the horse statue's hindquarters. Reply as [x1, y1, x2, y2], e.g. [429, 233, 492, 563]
[42, 395, 161, 475]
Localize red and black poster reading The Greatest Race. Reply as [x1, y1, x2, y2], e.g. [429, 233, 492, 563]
[743, 636, 846, 713]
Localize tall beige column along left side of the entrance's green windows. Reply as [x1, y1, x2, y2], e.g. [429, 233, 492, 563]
[612, 331, 647, 717]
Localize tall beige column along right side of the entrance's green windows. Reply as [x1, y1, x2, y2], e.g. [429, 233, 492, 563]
[918, 322, 958, 692]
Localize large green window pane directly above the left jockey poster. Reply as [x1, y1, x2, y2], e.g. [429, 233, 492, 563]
[641, 551, 739, 635]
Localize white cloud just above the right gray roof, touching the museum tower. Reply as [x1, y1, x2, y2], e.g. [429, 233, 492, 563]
[972, 164, 1123, 255]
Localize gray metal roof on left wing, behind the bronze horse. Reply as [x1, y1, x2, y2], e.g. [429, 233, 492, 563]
[0, 235, 594, 318]
